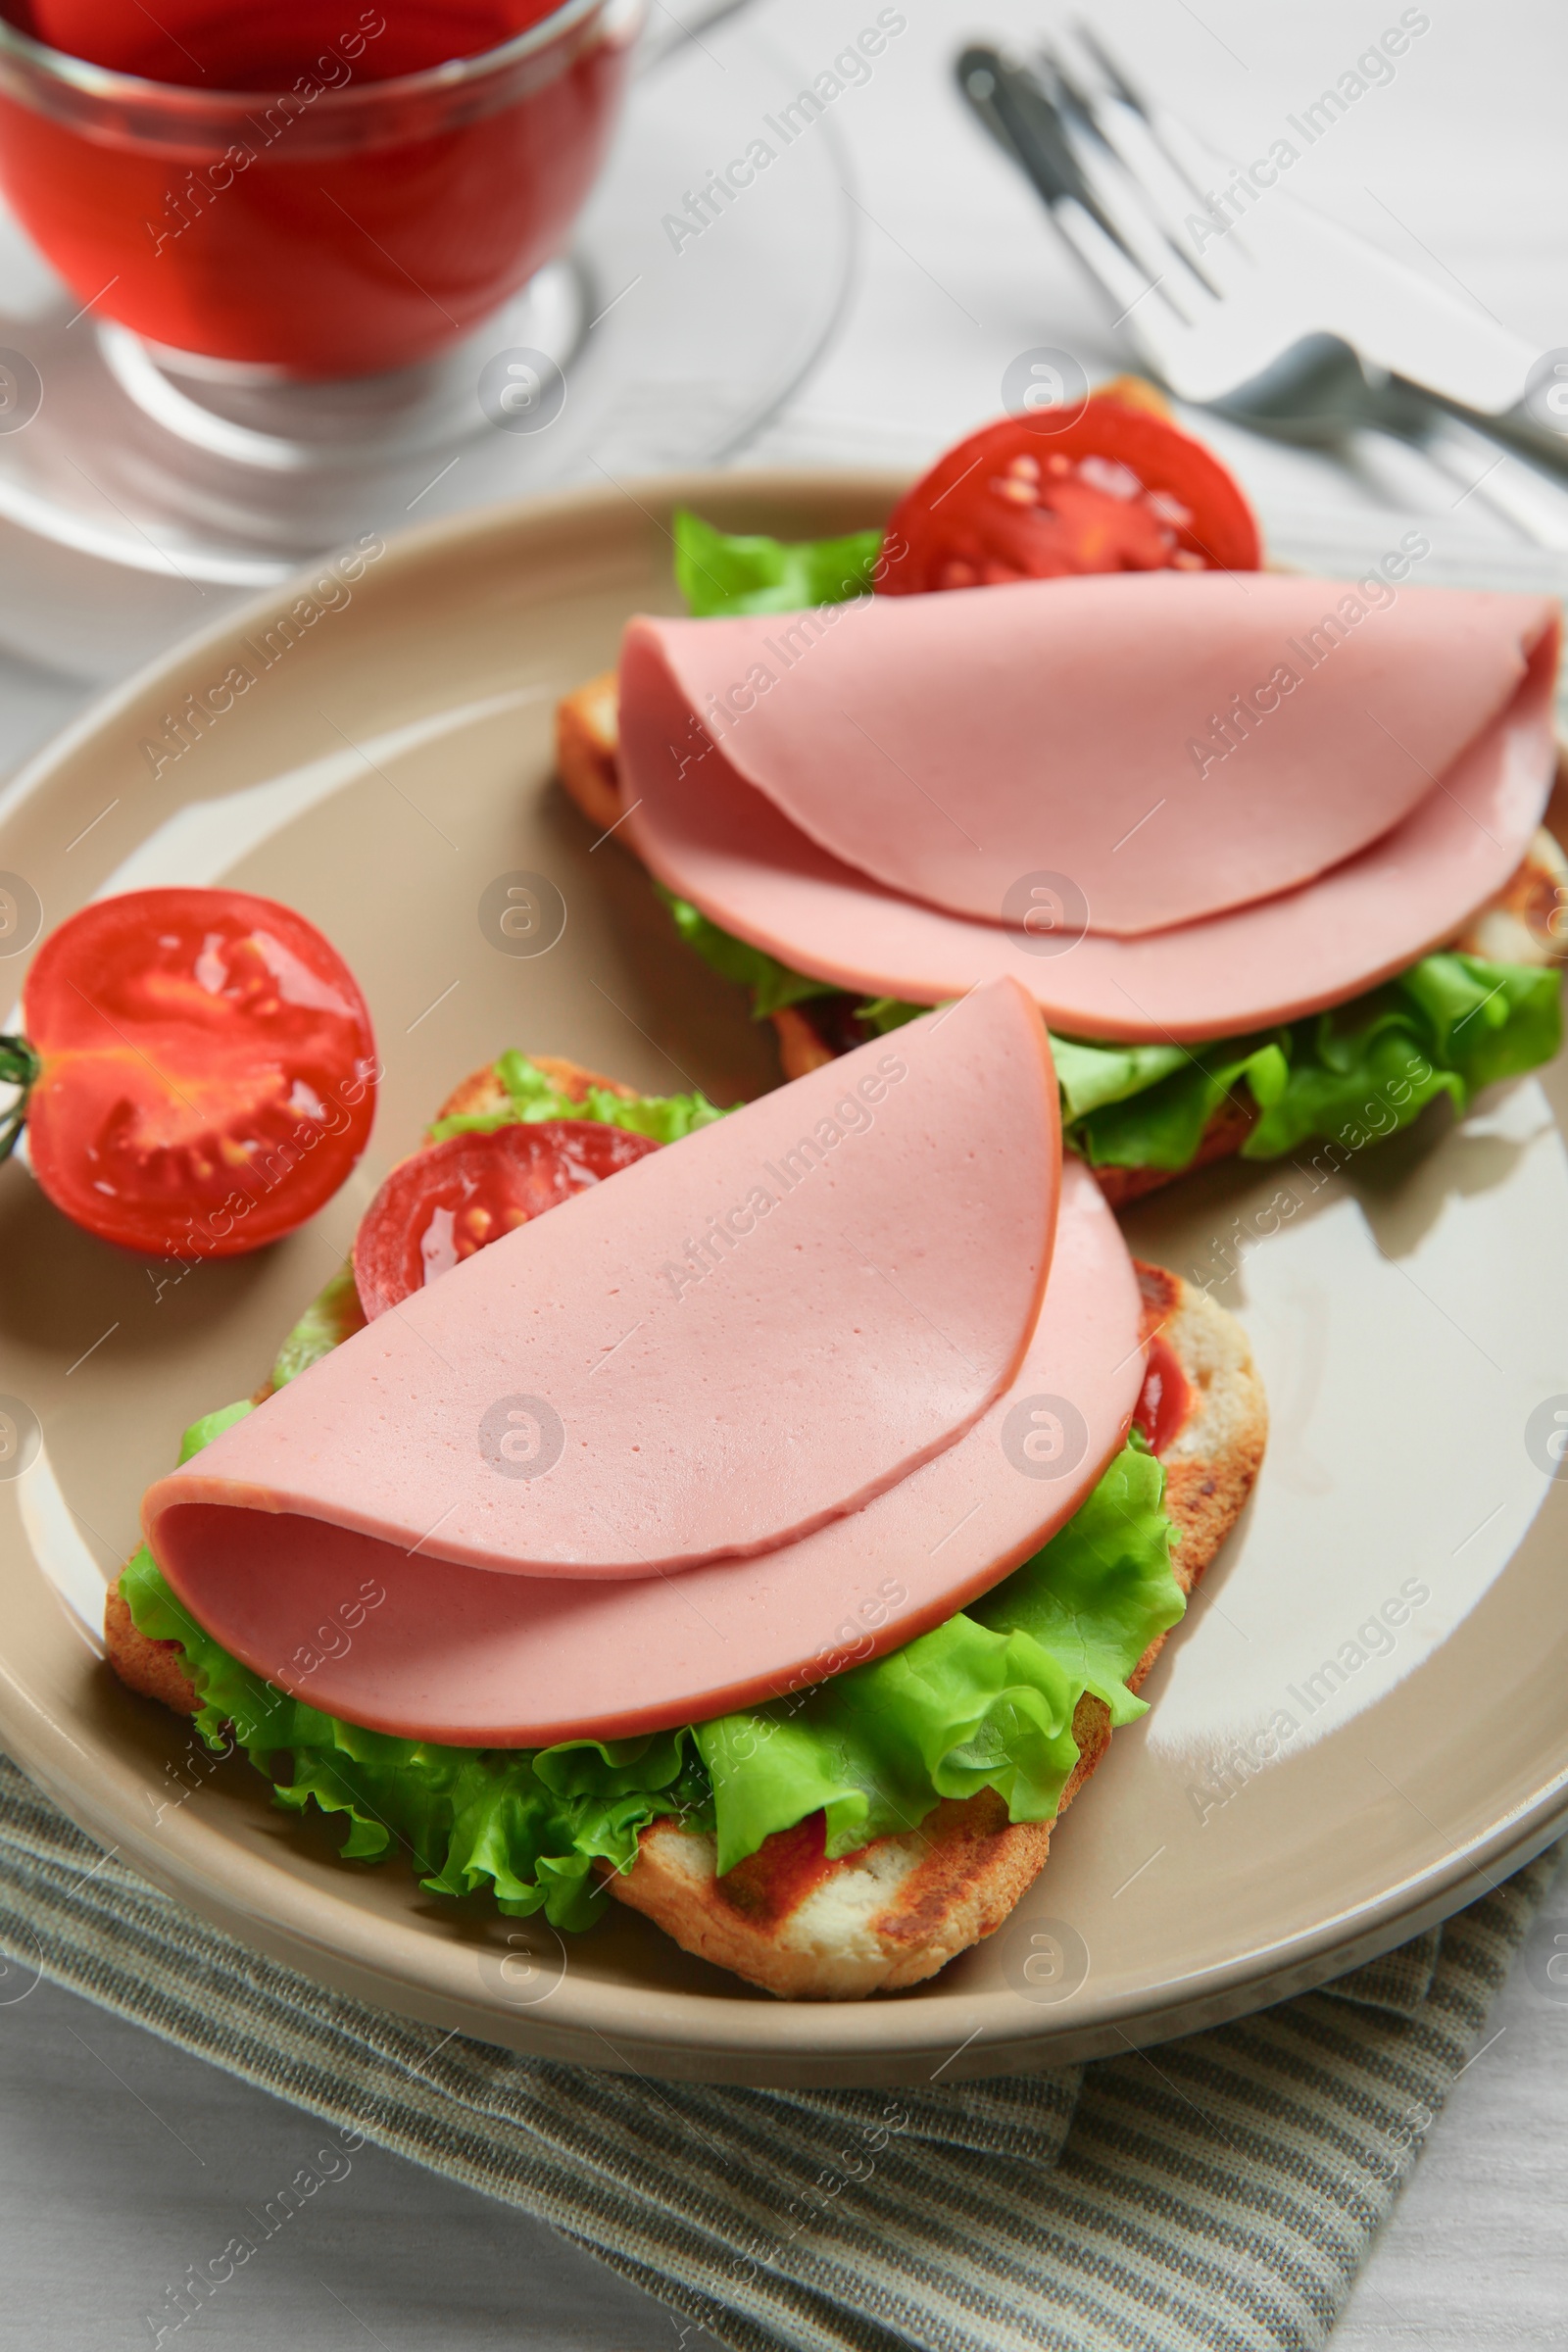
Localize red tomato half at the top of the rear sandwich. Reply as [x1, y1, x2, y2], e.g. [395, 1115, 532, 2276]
[877, 398, 1262, 595]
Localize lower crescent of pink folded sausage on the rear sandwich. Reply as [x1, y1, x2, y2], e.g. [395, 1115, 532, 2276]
[627, 615, 1556, 1042]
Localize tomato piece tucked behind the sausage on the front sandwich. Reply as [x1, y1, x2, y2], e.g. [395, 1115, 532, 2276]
[355, 1119, 659, 1322]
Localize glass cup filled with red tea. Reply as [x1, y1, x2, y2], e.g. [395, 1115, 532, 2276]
[0, 0, 642, 378]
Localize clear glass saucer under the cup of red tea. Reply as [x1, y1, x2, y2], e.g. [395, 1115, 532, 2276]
[0, 25, 854, 677]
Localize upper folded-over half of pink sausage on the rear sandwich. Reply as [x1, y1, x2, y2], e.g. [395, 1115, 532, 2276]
[620, 571, 1554, 939]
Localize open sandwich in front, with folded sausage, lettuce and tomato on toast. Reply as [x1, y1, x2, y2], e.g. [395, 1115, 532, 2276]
[106, 978, 1265, 1999]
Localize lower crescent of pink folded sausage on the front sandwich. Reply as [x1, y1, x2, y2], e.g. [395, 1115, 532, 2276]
[143, 1143, 1145, 1747]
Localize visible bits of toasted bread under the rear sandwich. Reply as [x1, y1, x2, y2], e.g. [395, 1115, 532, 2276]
[555, 677, 1568, 1209]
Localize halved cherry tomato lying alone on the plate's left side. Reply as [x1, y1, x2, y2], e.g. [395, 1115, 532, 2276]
[12, 889, 381, 1260]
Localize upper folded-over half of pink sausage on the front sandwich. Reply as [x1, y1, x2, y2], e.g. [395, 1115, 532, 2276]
[143, 981, 1060, 1592]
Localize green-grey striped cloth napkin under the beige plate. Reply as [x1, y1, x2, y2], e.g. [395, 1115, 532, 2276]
[0, 1757, 1556, 2352]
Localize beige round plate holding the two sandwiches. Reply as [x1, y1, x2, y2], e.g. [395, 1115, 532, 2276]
[0, 475, 1568, 2082]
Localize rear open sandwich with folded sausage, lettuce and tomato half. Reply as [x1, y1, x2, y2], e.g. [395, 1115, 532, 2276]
[558, 398, 1568, 1201]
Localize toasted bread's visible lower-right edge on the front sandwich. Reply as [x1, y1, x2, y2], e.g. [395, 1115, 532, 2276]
[607, 1265, 1267, 2001]
